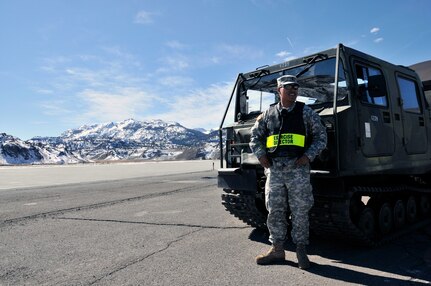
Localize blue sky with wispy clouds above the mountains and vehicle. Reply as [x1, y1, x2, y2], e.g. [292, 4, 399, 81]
[0, 0, 431, 140]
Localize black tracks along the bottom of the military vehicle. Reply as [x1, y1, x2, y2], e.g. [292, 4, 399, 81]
[222, 186, 431, 246]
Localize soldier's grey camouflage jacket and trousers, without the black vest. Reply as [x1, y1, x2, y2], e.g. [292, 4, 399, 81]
[250, 103, 327, 245]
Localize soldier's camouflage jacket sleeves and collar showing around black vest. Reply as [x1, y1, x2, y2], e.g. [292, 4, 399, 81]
[250, 103, 327, 161]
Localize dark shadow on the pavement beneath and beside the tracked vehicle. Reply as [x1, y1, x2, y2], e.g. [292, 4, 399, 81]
[249, 226, 431, 285]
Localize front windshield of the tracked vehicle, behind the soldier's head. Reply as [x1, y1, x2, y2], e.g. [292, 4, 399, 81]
[239, 58, 347, 115]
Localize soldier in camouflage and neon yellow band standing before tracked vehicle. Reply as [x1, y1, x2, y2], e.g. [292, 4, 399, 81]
[250, 75, 327, 269]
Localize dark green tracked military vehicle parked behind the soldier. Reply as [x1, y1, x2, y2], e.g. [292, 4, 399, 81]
[218, 44, 431, 245]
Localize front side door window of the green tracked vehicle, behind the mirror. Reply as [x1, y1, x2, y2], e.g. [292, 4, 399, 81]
[356, 64, 388, 106]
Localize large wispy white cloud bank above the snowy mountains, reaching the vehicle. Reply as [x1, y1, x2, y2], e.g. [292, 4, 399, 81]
[37, 47, 236, 128]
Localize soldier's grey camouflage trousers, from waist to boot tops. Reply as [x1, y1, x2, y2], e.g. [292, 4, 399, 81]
[265, 158, 314, 245]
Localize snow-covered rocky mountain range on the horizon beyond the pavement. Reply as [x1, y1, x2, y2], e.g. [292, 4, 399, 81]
[0, 119, 219, 164]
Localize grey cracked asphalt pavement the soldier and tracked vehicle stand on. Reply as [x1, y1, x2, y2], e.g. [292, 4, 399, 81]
[0, 162, 431, 286]
